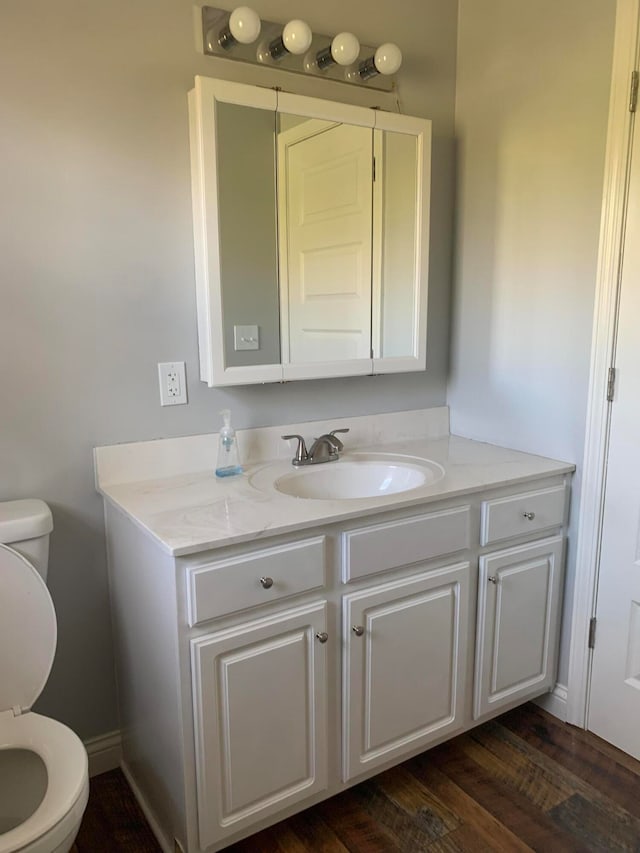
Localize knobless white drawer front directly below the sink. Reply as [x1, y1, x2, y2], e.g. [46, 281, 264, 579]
[342, 506, 470, 583]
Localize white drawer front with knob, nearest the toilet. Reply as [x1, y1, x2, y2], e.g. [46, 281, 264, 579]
[187, 536, 325, 627]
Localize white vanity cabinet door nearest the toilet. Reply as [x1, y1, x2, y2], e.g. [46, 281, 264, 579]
[191, 601, 329, 848]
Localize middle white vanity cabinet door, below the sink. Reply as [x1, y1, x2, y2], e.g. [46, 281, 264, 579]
[343, 563, 469, 781]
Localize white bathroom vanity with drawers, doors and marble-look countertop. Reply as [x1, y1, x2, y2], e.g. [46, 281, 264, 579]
[96, 413, 573, 853]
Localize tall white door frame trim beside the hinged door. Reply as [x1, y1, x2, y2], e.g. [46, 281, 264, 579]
[566, 0, 640, 728]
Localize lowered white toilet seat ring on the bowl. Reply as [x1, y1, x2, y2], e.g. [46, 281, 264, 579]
[0, 711, 88, 853]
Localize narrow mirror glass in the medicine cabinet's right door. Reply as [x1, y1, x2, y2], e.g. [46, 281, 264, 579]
[372, 130, 420, 358]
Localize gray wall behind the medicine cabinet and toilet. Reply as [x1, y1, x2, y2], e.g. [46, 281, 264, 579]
[0, 0, 457, 737]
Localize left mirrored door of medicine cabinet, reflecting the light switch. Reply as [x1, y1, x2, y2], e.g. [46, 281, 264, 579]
[189, 77, 282, 386]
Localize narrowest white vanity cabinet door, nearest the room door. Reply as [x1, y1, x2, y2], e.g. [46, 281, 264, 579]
[474, 536, 563, 719]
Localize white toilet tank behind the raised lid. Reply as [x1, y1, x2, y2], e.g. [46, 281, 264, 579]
[0, 499, 53, 580]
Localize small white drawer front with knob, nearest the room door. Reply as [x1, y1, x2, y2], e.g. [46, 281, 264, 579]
[480, 486, 567, 545]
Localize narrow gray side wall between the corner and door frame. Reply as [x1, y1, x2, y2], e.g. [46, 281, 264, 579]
[448, 0, 616, 683]
